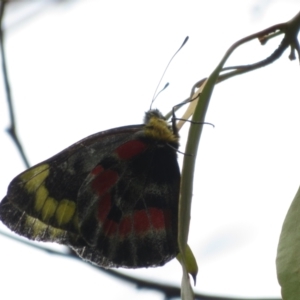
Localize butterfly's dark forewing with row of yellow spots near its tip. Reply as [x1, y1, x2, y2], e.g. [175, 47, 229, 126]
[0, 125, 143, 244]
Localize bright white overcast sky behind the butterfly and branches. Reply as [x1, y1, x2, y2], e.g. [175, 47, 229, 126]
[0, 0, 300, 300]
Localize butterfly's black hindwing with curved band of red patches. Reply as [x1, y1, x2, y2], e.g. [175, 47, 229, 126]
[77, 135, 180, 267]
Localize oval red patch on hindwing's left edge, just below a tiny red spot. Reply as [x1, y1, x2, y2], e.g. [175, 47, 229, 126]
[92, 167, 118, 196]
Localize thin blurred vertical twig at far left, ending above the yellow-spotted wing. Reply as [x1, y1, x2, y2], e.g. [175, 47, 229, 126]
[0, 0, 29, 168]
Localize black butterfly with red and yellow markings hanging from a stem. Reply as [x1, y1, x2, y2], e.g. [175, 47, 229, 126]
[0, 109, 180, 268]
